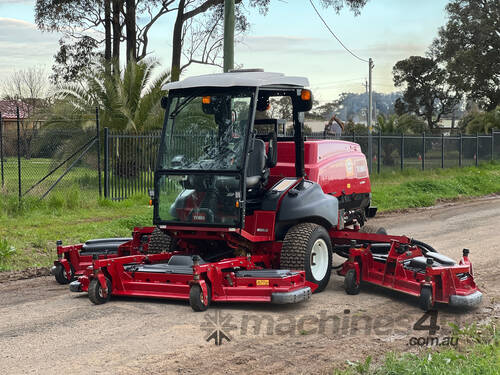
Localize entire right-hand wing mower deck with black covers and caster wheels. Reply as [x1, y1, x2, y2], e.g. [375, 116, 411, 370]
[337, 234, 482, 311]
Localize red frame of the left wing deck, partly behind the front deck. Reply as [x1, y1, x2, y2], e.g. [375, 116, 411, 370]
[54, 227, 154, 281]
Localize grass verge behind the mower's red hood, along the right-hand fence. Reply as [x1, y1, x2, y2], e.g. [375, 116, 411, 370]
[371, 163, 500, 211]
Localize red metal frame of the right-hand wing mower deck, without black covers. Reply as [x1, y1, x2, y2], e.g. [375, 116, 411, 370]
[338, 234, 482, 307]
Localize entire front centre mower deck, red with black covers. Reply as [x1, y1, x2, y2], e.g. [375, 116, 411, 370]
[70, 252, 316, 307]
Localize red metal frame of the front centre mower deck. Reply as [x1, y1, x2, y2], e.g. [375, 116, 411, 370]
[78, 252, 316, 302]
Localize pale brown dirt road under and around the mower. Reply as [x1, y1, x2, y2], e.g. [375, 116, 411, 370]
[0, 197, 500, 374]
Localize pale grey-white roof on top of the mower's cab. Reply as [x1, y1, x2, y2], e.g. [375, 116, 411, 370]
[162, 71, 309, 90]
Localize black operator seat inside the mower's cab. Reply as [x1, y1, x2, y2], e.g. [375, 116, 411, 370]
[246, 139, 269, 198]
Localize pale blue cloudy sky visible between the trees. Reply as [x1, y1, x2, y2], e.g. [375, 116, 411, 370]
[0, 0, 447, 102]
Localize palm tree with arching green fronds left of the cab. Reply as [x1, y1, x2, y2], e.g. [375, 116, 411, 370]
[48, 59, 170, 177]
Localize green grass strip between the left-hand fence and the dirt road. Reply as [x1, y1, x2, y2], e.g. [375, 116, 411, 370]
[0, 193, 153, 271]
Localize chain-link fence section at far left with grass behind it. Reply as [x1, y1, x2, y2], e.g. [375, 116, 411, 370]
[0, 110, 100, 206]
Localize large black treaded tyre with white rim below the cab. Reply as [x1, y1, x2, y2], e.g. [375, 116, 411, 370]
[280, 223, 332, 293]
